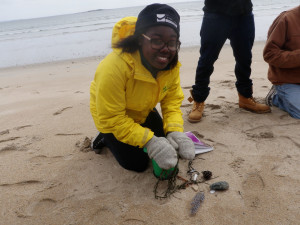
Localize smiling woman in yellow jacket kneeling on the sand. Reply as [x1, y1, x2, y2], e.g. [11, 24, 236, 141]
[90, 4, 195, 172]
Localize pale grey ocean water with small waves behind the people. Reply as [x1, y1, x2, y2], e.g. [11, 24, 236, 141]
[0, 0, 300, 68]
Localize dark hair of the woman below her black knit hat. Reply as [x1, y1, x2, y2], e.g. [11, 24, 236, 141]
[113, 32, 179, 69]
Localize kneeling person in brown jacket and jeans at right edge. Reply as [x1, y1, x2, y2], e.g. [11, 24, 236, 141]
[263, 6, 300, 119]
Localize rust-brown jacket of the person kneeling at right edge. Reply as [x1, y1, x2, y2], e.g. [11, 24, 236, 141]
[263, 6, 300, 84]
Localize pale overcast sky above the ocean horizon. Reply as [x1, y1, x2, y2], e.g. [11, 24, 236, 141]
[0, 0, 197, 21]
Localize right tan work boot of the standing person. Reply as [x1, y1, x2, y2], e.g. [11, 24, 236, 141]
[238, 94, 271, 113]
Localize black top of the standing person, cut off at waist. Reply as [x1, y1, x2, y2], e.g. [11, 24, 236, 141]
[203, 0, 252, 16]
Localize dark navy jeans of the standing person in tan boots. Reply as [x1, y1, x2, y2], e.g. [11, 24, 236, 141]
[192, 13, 255, 102]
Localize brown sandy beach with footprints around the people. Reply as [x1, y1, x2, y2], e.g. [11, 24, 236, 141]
[0, 42, 300, 225]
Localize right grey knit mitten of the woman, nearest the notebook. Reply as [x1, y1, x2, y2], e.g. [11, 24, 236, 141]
[167, 131, 195, 160]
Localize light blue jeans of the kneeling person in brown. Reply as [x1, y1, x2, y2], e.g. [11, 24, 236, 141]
[272, 84, 300, 119]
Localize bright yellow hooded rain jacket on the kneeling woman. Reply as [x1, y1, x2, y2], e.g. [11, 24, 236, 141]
[90, 17, 184, 147]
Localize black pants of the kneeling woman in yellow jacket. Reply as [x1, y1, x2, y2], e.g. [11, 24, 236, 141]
[102, 108, 165, 172]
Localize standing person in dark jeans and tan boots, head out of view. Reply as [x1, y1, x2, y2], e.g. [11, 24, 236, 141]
[188, 0, 270, 122]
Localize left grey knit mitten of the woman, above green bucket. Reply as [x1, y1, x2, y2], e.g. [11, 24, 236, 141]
[144, 136, 178, 170]
